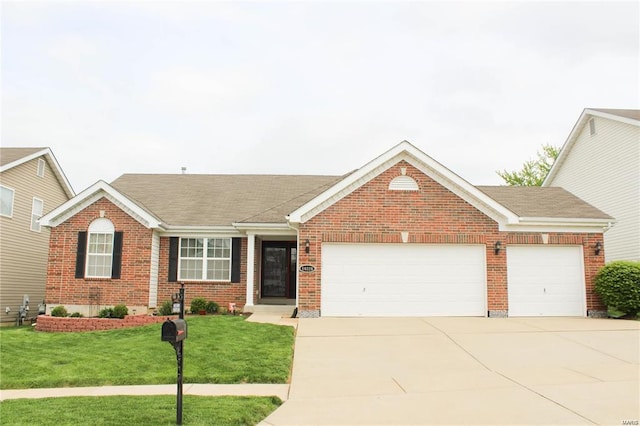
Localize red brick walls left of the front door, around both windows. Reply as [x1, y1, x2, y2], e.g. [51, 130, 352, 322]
[45, 198, 247, 315]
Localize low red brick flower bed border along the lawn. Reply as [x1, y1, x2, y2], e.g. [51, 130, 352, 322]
[36, 315, 177, 332]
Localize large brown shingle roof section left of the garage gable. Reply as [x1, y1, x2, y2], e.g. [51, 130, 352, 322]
[111, 174, 342, 226]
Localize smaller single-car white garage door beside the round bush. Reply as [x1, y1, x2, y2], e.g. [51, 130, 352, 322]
[507, 246, 586, 317]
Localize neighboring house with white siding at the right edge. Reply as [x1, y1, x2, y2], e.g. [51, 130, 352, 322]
[542, 109, 640, 262]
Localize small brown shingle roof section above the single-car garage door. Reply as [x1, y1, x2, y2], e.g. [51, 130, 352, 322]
[476, 186, 613, 220]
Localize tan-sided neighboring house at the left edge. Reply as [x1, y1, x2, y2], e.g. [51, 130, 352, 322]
[0, 148, 75, 325]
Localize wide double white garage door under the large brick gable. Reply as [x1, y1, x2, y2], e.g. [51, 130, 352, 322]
[321, 244, 486, 316]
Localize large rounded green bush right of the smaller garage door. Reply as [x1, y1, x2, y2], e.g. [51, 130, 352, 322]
[595, 261, 640, 316]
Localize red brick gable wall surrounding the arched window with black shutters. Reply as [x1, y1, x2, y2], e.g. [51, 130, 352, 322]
[45, 198, 152, 306]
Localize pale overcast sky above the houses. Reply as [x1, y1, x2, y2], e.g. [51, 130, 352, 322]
[0, 1, 640, 192]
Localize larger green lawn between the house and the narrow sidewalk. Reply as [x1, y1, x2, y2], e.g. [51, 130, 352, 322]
[0, 315, 294, 389]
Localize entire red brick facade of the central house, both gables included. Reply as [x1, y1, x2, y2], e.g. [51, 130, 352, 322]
[46, 161, 604, 320]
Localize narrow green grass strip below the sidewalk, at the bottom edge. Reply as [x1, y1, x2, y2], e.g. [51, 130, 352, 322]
[0, 395, 282, 426]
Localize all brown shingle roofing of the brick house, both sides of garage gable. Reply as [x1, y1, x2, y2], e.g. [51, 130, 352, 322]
[111, 174, 612, 226]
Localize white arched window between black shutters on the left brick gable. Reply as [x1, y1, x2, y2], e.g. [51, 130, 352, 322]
[85, 218, 115, 278]
